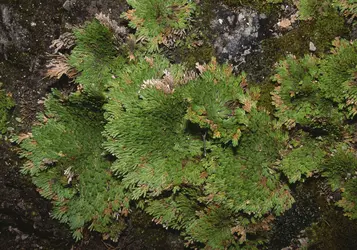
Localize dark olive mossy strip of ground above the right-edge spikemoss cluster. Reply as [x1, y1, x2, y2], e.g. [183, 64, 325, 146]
[247, 6, 350, 112]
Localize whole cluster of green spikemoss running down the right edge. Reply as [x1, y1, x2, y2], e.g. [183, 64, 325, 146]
[272, 39, 357, 218]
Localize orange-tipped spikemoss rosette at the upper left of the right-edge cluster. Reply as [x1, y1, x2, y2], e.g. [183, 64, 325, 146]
[272, 55, 343, 132]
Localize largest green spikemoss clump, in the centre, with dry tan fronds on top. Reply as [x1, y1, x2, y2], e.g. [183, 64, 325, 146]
[105, 58, 293, 249]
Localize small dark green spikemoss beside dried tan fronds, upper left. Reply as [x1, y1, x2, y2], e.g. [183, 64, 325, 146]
[69, 19, 125, 96]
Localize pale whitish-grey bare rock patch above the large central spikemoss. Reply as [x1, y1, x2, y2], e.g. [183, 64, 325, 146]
[211, 5, 266, 68]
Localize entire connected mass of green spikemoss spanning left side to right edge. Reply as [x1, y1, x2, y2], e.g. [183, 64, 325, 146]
[17, 0, 357, 249]
